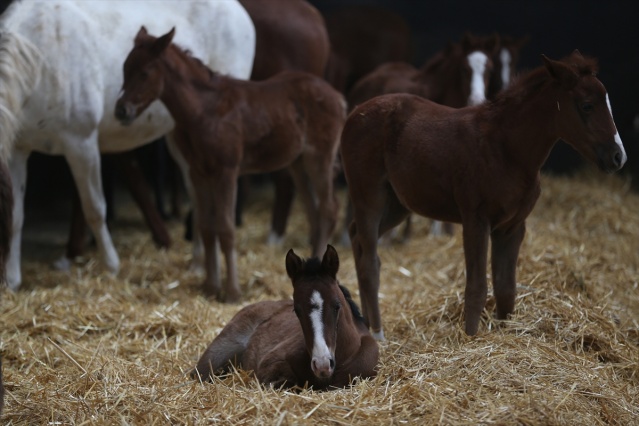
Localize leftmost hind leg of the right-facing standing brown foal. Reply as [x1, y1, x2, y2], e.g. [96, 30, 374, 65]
[349, 182, 408, 340]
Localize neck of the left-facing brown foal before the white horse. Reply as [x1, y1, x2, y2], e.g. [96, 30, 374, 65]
[160, 46, 221, 123]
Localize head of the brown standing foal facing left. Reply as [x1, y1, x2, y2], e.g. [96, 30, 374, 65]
[115, 26, 175, 125]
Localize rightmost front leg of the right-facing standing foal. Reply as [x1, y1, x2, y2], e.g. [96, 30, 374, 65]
[491, 222, 526, 319]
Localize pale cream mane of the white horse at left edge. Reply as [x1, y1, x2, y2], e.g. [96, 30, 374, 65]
[0, 31, 43, 160]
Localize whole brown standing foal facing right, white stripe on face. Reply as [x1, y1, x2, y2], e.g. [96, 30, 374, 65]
[341, 51, 627, 340]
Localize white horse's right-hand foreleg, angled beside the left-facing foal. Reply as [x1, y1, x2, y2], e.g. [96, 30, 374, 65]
[65, 135, 120, 274]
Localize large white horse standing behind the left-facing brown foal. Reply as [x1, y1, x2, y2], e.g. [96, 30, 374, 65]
[0, 0, 255, 289]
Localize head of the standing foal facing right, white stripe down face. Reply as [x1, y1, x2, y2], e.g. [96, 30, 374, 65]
[542, 50, 627, 173]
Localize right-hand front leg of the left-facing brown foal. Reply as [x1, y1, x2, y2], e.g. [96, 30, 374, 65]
[209, 169, 241, 303]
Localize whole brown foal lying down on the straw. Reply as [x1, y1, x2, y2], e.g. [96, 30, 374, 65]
[191, 245, 379, 390]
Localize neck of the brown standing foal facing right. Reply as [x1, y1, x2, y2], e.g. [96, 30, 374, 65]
[479, 76, 568, 176]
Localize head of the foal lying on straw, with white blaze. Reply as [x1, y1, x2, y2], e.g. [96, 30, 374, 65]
[286, 245, 348, 379]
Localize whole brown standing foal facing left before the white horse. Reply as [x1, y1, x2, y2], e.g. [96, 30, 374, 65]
[115, 27, 346, 302]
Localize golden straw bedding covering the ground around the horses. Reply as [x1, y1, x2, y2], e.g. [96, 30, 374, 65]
[0, 168, 639, 425]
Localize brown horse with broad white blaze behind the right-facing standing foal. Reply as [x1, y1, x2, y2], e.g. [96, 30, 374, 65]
[343, 33, 499, 241]
